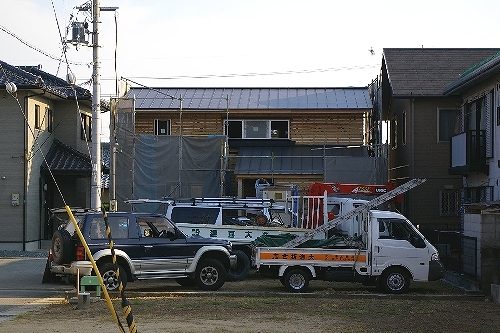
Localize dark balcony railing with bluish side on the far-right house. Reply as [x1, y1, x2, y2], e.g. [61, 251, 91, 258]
[450, 130, 488, 175]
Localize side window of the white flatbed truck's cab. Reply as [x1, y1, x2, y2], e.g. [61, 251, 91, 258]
[378, 218, 425, 248]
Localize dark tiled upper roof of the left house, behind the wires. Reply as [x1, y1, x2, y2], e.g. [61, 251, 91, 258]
[0, 60, 91, 100]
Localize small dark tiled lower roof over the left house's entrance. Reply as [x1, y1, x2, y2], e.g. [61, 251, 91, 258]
[41, 140, 92, 175]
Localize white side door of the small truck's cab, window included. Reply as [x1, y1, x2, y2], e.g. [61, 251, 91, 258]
[372, 218, 430, 281]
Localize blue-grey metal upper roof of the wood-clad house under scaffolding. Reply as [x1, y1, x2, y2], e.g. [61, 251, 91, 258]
[126, 87, 372, 111]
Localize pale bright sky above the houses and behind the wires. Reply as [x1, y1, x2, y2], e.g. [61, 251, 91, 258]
[0, 0, 500, 135]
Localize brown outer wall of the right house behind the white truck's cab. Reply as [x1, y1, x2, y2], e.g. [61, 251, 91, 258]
[389, 98, 461, 228]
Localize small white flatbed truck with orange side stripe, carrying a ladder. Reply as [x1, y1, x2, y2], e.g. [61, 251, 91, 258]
[254, 178, 444, 294]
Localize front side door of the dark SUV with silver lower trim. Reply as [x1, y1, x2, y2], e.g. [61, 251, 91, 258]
[136, 216, 189, 277]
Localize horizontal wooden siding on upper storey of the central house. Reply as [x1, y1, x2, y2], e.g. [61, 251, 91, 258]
[135, 110, 364, 145]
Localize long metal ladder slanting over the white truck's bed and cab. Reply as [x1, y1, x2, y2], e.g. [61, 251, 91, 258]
[282, 178, 426, 247]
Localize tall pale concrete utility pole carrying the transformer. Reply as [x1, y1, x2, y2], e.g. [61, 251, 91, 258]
[90, 0, 101, 209]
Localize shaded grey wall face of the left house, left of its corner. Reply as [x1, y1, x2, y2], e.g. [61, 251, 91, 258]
[0, 90, 26, 249]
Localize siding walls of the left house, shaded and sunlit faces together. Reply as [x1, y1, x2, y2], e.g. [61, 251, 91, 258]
[0, 90, 92, 250]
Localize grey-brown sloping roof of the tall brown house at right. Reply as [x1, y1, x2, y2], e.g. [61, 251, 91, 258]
[383, 48, 500, 96]
